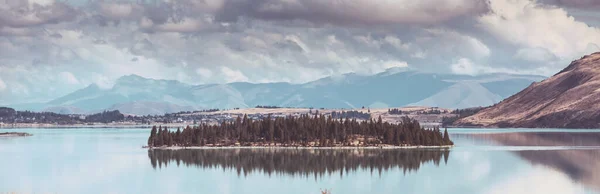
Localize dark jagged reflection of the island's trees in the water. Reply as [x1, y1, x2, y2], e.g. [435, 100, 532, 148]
[148, 149, 450, 177]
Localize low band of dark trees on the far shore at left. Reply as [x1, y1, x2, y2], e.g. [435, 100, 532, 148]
[0, 107, 125, 125]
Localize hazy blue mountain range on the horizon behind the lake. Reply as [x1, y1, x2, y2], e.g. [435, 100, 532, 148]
[12, 68, 544, 115]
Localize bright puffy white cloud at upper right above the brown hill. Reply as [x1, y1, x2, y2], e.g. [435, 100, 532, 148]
[478, 0, 600, 59]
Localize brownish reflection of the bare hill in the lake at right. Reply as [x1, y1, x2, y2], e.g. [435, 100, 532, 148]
[460, 132, 600, 191]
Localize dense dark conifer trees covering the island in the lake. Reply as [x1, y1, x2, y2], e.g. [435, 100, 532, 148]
[148, 115, 453, 147]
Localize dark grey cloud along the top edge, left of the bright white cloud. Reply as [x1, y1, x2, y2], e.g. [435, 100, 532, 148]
[217, 0, 488, 25]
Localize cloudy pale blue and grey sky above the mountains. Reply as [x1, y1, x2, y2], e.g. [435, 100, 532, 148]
[0, 0, 600, 104]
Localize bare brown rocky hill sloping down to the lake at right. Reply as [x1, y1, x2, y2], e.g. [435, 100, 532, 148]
[455, 52, 600, 128]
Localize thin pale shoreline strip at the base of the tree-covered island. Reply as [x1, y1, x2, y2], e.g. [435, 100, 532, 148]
[142, 145, 454, 150]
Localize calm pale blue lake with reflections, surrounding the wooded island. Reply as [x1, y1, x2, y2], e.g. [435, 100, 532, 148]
[0, 129, 600, 194]
